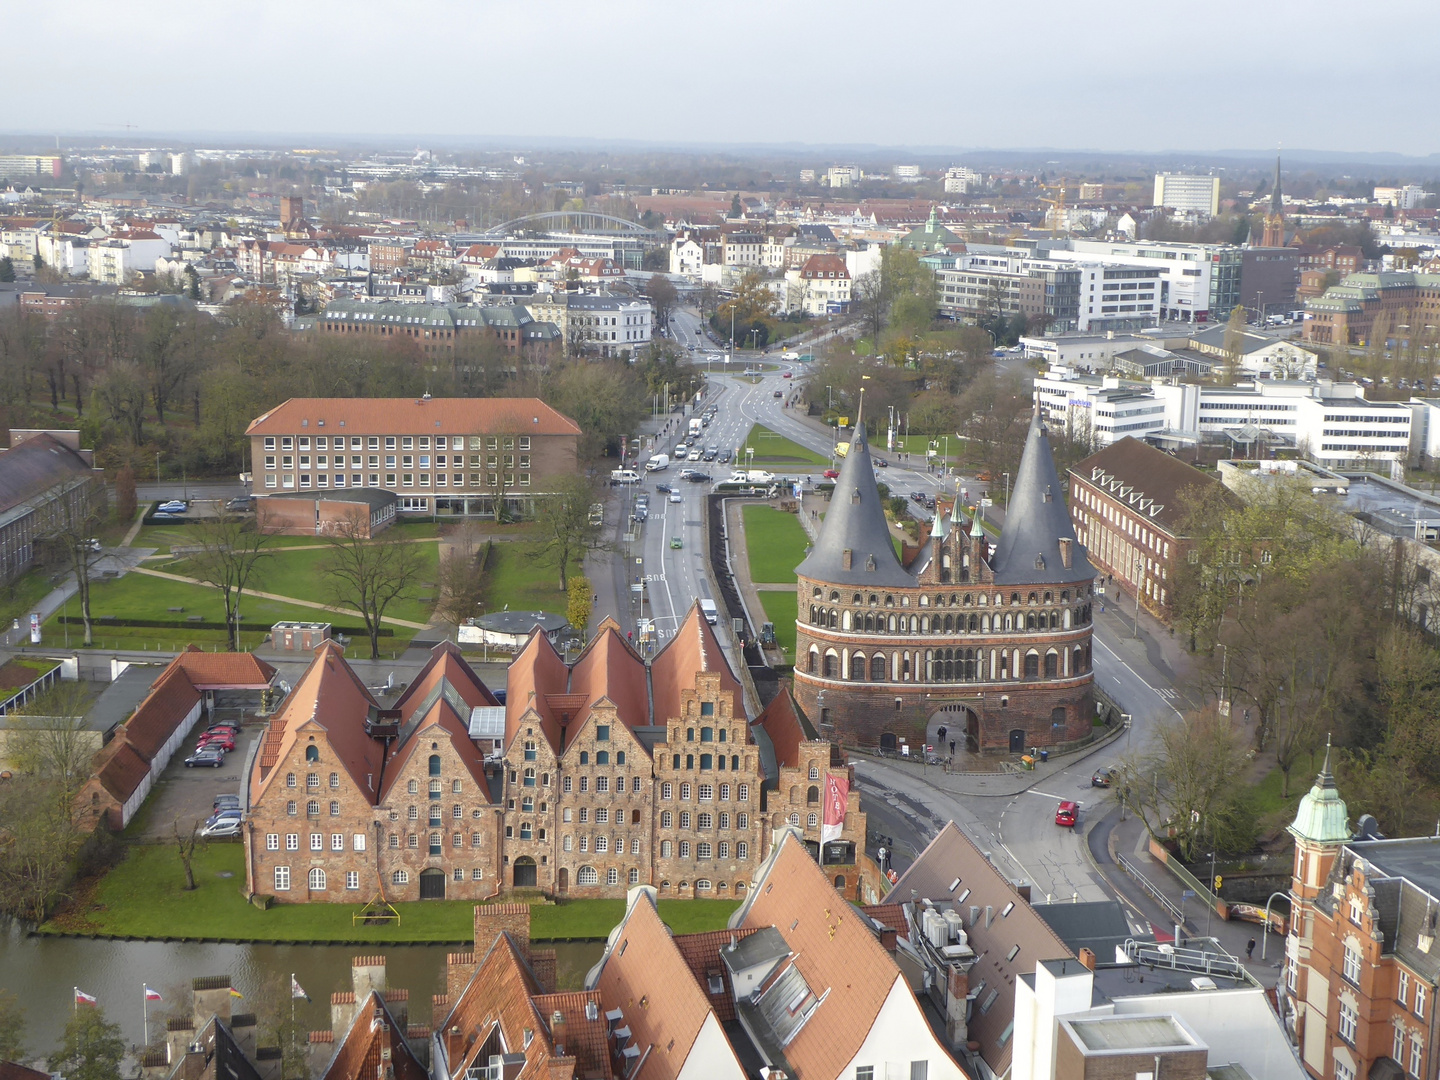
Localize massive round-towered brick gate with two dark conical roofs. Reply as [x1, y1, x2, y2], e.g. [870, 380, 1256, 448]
[795, 408, 1094, 755]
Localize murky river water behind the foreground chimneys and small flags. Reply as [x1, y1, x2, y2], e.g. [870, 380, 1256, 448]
[0, 923, 603, 1056]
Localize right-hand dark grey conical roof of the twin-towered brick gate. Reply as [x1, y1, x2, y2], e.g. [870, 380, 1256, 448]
[991, 410, 1094, 585]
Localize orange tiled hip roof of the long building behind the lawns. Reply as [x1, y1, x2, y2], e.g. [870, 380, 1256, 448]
[245, 397, 580, 435]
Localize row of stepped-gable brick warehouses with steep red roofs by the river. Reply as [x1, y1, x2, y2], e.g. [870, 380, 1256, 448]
[245, 608, 865, 901]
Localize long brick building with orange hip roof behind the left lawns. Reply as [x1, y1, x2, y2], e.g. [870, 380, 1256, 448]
[246, 397, 580, 517]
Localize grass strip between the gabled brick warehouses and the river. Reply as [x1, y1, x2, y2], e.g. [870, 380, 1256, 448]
[40, 841, 737, 943]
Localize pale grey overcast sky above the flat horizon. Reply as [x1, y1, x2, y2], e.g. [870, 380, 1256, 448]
[11, 0, 1440, 154]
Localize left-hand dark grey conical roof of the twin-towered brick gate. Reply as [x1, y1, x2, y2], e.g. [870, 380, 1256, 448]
[796, 410, 916, 589]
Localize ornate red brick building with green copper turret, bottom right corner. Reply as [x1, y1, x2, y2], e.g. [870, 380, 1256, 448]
[1280, 747, 1440, 1080]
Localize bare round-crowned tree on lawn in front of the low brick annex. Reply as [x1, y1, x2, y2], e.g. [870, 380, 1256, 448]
[328, 508, 425, 660]
